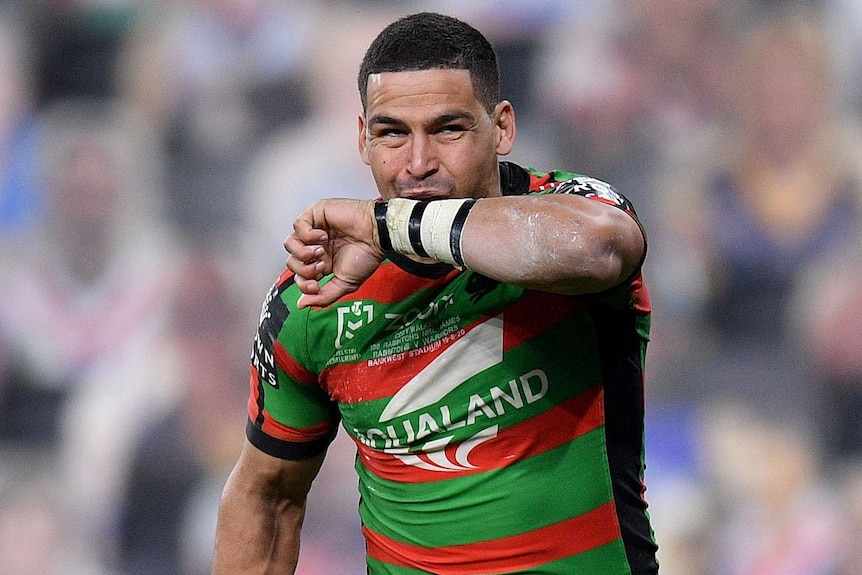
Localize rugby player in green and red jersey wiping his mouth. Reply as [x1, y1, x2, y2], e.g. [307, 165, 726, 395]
[214, 13, 657, 575]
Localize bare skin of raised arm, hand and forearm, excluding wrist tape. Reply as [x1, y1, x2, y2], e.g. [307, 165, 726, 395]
[285, 194, 645, 305]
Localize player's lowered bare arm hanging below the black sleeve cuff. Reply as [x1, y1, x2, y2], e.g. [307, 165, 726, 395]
[213, 440, 323, 575]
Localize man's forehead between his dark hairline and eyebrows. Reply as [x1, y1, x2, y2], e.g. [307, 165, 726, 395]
[366, 69, 482, 117]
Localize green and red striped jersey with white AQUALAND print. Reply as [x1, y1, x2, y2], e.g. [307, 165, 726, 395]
[248, 163, 657, 575]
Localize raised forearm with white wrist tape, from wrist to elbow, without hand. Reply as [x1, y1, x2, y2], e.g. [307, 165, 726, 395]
[378, 195, 644, 294]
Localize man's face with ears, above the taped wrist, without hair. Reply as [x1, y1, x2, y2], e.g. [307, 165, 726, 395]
[359, 70, 515, 200]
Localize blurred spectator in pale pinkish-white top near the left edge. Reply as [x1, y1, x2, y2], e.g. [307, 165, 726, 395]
[0, 98, 178, 447]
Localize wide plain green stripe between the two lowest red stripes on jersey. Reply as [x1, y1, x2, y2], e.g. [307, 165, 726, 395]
[357, 427, 612, 548]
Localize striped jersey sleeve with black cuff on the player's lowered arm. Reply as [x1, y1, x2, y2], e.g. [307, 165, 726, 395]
[246, 274, 339, 459]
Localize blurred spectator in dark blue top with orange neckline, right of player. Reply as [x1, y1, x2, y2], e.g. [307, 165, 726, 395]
[651, 4, 862, 426]
